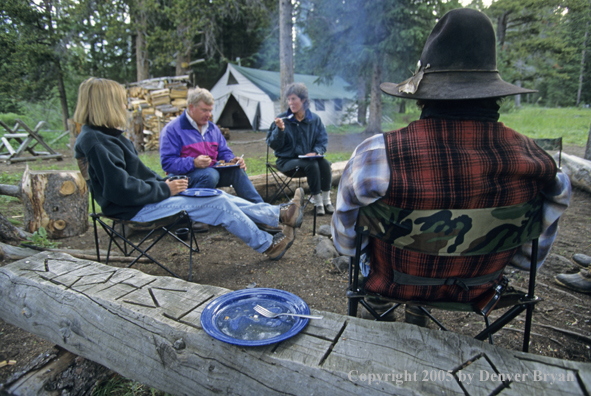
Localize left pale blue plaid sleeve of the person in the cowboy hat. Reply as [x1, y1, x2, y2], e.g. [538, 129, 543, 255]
[331, 134, 390, 256]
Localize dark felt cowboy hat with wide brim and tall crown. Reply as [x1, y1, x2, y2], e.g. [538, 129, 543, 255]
[380, 8, 537, 100]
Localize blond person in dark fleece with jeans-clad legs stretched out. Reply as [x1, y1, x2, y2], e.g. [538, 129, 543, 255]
[74, 77, 304, 260]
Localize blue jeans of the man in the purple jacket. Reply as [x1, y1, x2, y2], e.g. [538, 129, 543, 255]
[182, 168, 263, 203]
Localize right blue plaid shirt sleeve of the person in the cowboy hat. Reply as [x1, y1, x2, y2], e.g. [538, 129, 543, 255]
[511, 170, 572, 270]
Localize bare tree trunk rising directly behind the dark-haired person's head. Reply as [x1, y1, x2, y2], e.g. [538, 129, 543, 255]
[279, 0, 293, 112]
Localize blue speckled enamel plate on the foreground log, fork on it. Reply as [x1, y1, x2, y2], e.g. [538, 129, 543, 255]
[201, 288, 310, 346]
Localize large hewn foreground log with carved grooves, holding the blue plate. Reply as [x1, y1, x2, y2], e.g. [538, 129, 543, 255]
[0, 252, 591, 396]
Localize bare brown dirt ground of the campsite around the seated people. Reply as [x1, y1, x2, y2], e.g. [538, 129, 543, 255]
[0, 132, 591, 384]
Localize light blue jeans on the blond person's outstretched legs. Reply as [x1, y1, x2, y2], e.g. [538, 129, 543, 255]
[131, 192, 279, 253]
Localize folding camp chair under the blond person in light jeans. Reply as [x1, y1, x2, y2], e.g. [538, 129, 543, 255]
[78, 158, 199, 281]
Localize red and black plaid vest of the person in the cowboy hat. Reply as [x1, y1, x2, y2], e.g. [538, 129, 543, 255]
[365, 119, 557, 302]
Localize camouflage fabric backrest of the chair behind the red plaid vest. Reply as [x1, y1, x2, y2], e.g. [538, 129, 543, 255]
[356, 196, 543, 256]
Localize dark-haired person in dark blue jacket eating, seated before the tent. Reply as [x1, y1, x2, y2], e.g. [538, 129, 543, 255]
[267, 83, 334, 216]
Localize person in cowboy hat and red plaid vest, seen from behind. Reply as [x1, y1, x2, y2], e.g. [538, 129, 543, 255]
[332, 8, 570, 318]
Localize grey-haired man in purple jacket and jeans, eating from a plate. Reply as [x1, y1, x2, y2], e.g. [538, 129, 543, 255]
[160, 88, 263, 203]
